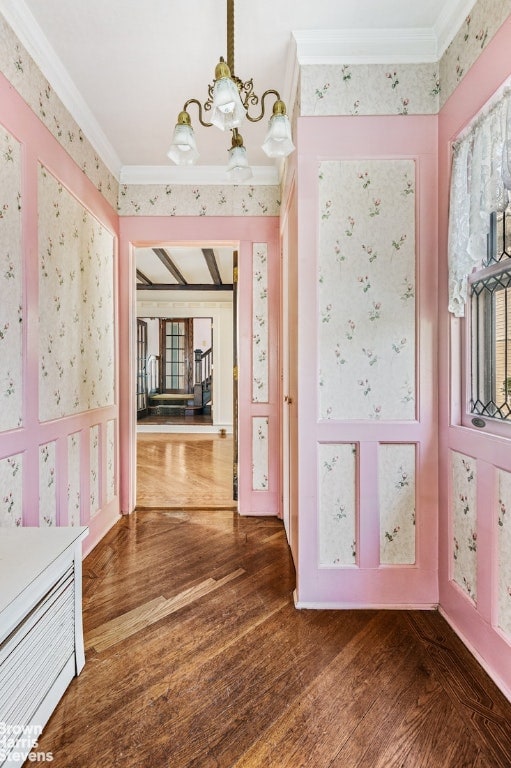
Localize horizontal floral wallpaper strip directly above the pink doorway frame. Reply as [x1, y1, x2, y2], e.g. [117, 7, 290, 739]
[118, 184, 280, 216]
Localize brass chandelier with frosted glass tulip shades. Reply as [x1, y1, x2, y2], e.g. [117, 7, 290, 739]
[167, 0, 295, 182]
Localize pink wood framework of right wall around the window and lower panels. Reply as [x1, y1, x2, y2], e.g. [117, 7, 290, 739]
[439, 18, 511, 698]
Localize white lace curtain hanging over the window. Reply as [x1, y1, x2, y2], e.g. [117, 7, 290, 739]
[448, 88, 511, 317]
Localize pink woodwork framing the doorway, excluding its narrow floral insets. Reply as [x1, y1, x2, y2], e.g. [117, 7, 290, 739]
[119, 216, 280, 515]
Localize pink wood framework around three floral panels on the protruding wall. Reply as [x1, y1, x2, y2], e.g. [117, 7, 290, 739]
[295, 111, 438, 608]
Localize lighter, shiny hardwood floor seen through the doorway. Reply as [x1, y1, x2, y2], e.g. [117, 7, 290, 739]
[137, 433, 237, 509]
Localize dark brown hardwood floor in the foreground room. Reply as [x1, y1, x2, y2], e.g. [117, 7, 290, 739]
[38, 510, 511, 768]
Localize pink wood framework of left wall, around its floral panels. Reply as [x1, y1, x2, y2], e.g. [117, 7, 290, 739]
[0, 75, 119, 552]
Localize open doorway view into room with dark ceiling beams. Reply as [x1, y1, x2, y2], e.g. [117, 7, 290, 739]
[135, 245, 237, 509]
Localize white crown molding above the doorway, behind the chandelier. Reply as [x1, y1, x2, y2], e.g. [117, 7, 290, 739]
[119, 165, 280, 187]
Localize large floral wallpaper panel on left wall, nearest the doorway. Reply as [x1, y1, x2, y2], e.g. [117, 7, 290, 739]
[39, 166, 114, 421]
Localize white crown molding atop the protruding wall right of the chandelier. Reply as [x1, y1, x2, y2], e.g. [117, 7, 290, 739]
[293, 29, 438, 65]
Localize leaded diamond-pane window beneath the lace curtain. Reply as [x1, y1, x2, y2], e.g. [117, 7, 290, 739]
[469, 206, 511, 422]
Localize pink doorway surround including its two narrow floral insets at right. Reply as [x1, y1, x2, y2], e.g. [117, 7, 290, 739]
[119, 216, 281, 517]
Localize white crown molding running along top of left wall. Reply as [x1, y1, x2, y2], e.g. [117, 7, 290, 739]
[0, 0, 121, 179]
